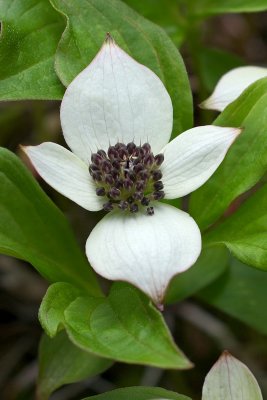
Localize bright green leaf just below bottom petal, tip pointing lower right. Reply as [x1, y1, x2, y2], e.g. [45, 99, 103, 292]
[64, 284, 191, 369]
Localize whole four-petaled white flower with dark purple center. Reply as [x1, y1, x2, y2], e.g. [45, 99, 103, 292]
[25, 36, 240, 304]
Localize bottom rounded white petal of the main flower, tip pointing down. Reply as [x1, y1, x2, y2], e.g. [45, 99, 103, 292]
[86, 203, 201, 304]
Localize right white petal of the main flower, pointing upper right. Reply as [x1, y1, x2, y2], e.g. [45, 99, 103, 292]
[161, 125, 241, 199]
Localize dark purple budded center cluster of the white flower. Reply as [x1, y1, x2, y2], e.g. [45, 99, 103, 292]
[89, 142, 165, 215]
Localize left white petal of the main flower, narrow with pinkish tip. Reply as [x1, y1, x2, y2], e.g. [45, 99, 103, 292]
[23, 142, 103, 211]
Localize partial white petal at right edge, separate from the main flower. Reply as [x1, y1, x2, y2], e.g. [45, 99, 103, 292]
[200, 66, 267, 111]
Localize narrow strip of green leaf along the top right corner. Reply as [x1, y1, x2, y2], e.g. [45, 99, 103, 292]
[190, 0, 267, 17]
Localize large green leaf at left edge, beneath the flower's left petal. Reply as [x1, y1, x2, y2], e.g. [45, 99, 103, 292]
[0, 148, 100, 295]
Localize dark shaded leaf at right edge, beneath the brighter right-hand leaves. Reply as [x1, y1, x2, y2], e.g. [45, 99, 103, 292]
[198, 259, 267, 334]
